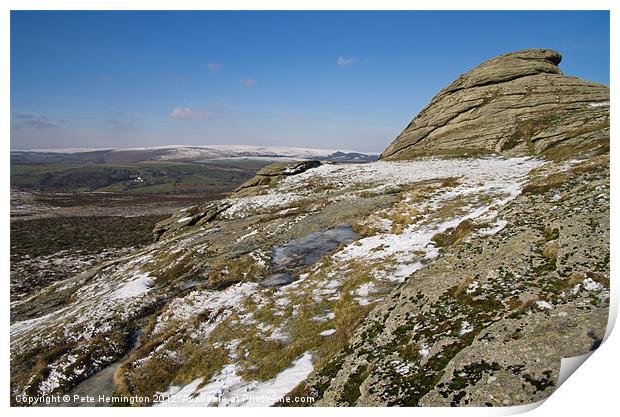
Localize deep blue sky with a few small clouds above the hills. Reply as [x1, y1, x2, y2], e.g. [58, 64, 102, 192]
[11, 11, 609, 151]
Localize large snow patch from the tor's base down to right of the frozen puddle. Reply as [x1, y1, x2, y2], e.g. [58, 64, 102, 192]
[330, 158, 541, 282]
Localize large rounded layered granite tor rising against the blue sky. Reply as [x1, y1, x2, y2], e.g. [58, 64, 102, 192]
[381, 49, 609, 160]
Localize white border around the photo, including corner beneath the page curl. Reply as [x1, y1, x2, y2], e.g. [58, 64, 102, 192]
[0, 0, 620, 417]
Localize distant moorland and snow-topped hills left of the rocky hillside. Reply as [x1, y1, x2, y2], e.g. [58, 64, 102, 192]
[10, 146, 376, 300]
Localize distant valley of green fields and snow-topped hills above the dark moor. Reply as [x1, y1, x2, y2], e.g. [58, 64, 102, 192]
[11, 145, 378, 194]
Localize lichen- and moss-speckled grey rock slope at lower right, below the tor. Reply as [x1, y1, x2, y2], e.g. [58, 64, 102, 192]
[296, 156, 610, 406]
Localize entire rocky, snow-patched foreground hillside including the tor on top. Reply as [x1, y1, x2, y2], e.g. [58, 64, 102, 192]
[10, 49, 610, 406]
